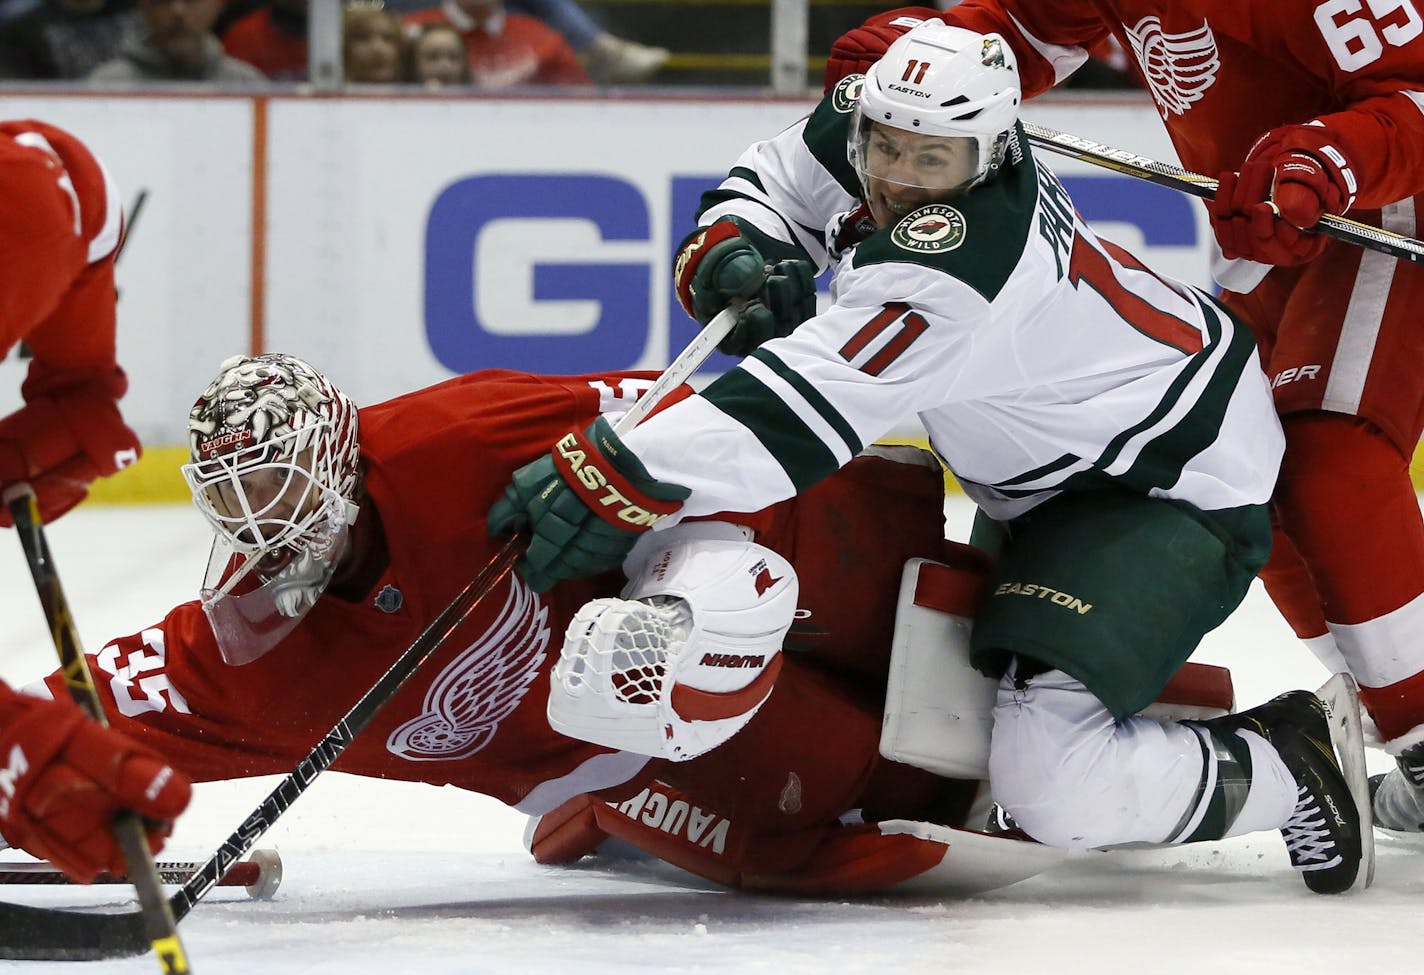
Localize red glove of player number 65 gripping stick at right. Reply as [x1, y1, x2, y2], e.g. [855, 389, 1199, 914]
[1208, 125, 1357, 266]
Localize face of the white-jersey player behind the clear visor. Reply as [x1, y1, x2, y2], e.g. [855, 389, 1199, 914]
[864, 124, 975, 226]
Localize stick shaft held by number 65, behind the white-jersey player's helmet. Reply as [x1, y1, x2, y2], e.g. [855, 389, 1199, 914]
[1024, 122, 1424, 263]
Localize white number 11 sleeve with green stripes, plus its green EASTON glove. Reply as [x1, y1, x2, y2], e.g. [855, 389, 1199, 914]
[488, 265, 987, 591]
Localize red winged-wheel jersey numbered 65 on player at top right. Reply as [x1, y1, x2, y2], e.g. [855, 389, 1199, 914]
[943, 0, 1424, 207]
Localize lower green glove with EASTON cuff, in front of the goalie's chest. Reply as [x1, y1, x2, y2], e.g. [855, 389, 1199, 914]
[488, 417, 691, 592]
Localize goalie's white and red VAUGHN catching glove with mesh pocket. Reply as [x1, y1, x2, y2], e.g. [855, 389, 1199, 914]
[548, 522, 797, 761]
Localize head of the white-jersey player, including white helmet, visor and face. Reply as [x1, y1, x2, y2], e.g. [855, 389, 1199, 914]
[846, 20, 1022, 213]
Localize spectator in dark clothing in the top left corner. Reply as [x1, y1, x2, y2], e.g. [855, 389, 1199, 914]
[0, 0, 142, 81]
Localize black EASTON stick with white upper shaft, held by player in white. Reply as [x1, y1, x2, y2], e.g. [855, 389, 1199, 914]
[0, 306, 739, 961]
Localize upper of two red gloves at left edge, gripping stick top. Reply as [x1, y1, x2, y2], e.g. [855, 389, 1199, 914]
[0, 381, 141, 528]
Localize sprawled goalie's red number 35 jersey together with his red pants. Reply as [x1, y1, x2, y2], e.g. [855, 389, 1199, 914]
[48, 371, 979, 884]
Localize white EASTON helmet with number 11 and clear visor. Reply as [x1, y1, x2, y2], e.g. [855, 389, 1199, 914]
[847, 20, 1022, 194]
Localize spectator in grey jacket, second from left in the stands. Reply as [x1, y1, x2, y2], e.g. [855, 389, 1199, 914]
[88, 0, 266, 84]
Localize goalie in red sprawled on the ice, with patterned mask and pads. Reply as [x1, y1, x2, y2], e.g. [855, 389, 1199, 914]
[0, 354, 1230, 895]
